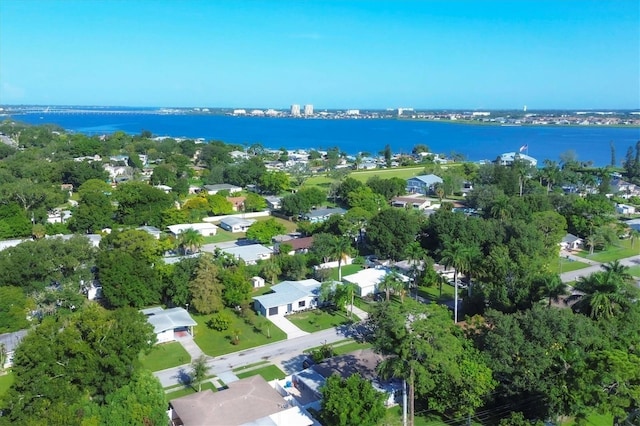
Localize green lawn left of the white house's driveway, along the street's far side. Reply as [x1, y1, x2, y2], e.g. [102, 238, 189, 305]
[192, 309, 287, 356]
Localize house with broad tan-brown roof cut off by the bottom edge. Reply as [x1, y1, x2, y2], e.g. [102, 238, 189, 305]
[168, 375, 318, 426]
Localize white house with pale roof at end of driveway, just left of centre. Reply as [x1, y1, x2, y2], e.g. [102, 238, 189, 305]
[253, 279, 320, 317]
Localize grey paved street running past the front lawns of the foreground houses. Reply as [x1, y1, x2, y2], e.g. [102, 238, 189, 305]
[154, 326, 358, 387]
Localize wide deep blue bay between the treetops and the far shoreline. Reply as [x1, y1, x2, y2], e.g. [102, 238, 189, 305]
[6, 112, 640, 166]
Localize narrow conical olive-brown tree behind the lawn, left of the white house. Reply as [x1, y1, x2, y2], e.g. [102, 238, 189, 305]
[189, 253, 224, 314]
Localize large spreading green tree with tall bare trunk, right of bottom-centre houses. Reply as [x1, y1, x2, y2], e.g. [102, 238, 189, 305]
[367, 300, 496, 425]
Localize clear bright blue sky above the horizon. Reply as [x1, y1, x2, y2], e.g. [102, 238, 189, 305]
[0, 0, 640, 109]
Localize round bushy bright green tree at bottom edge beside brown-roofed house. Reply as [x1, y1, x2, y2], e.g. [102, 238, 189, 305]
[320, 373, 385, 426]
